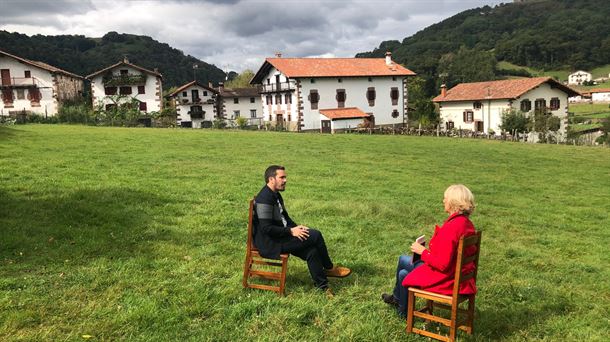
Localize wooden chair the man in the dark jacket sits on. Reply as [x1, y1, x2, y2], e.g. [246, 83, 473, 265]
[242, 199, 290, 296]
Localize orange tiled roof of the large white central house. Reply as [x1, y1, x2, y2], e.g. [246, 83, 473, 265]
[250, 58, 416, 83]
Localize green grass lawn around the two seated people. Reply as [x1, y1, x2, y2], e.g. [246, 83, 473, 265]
[0, 125, 610, 341]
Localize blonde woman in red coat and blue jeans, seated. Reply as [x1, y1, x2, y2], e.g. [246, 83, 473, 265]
[381, 184, 477, 316]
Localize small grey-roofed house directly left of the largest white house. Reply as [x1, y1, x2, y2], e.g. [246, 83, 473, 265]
[218, 83, 263, 125]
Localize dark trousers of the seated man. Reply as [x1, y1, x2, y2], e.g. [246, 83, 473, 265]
[282, 228, 333, 289]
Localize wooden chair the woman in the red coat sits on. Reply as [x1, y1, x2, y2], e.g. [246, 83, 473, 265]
[406, 232, 481, 341]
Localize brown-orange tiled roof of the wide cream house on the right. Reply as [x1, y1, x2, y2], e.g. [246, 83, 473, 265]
[432, 77, 580, 102]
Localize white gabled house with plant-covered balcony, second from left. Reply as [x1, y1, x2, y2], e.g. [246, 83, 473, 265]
[86, 58, 163, 112]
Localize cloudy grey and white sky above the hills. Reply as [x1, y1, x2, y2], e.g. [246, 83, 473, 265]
[0, 0, 498, 72]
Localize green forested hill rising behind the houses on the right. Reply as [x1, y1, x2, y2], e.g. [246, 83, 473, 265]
[357, 0, 610, 95]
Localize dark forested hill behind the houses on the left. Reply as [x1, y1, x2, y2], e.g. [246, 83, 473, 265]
[0, 31, 225, 89]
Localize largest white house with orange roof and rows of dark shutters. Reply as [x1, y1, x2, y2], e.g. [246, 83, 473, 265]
[251, 52, 415, 133]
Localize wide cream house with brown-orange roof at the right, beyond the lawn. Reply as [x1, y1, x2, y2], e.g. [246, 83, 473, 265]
[432, 77, 579, 134]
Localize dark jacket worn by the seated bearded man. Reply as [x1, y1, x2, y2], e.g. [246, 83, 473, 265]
[253, 185, 297, 259]
